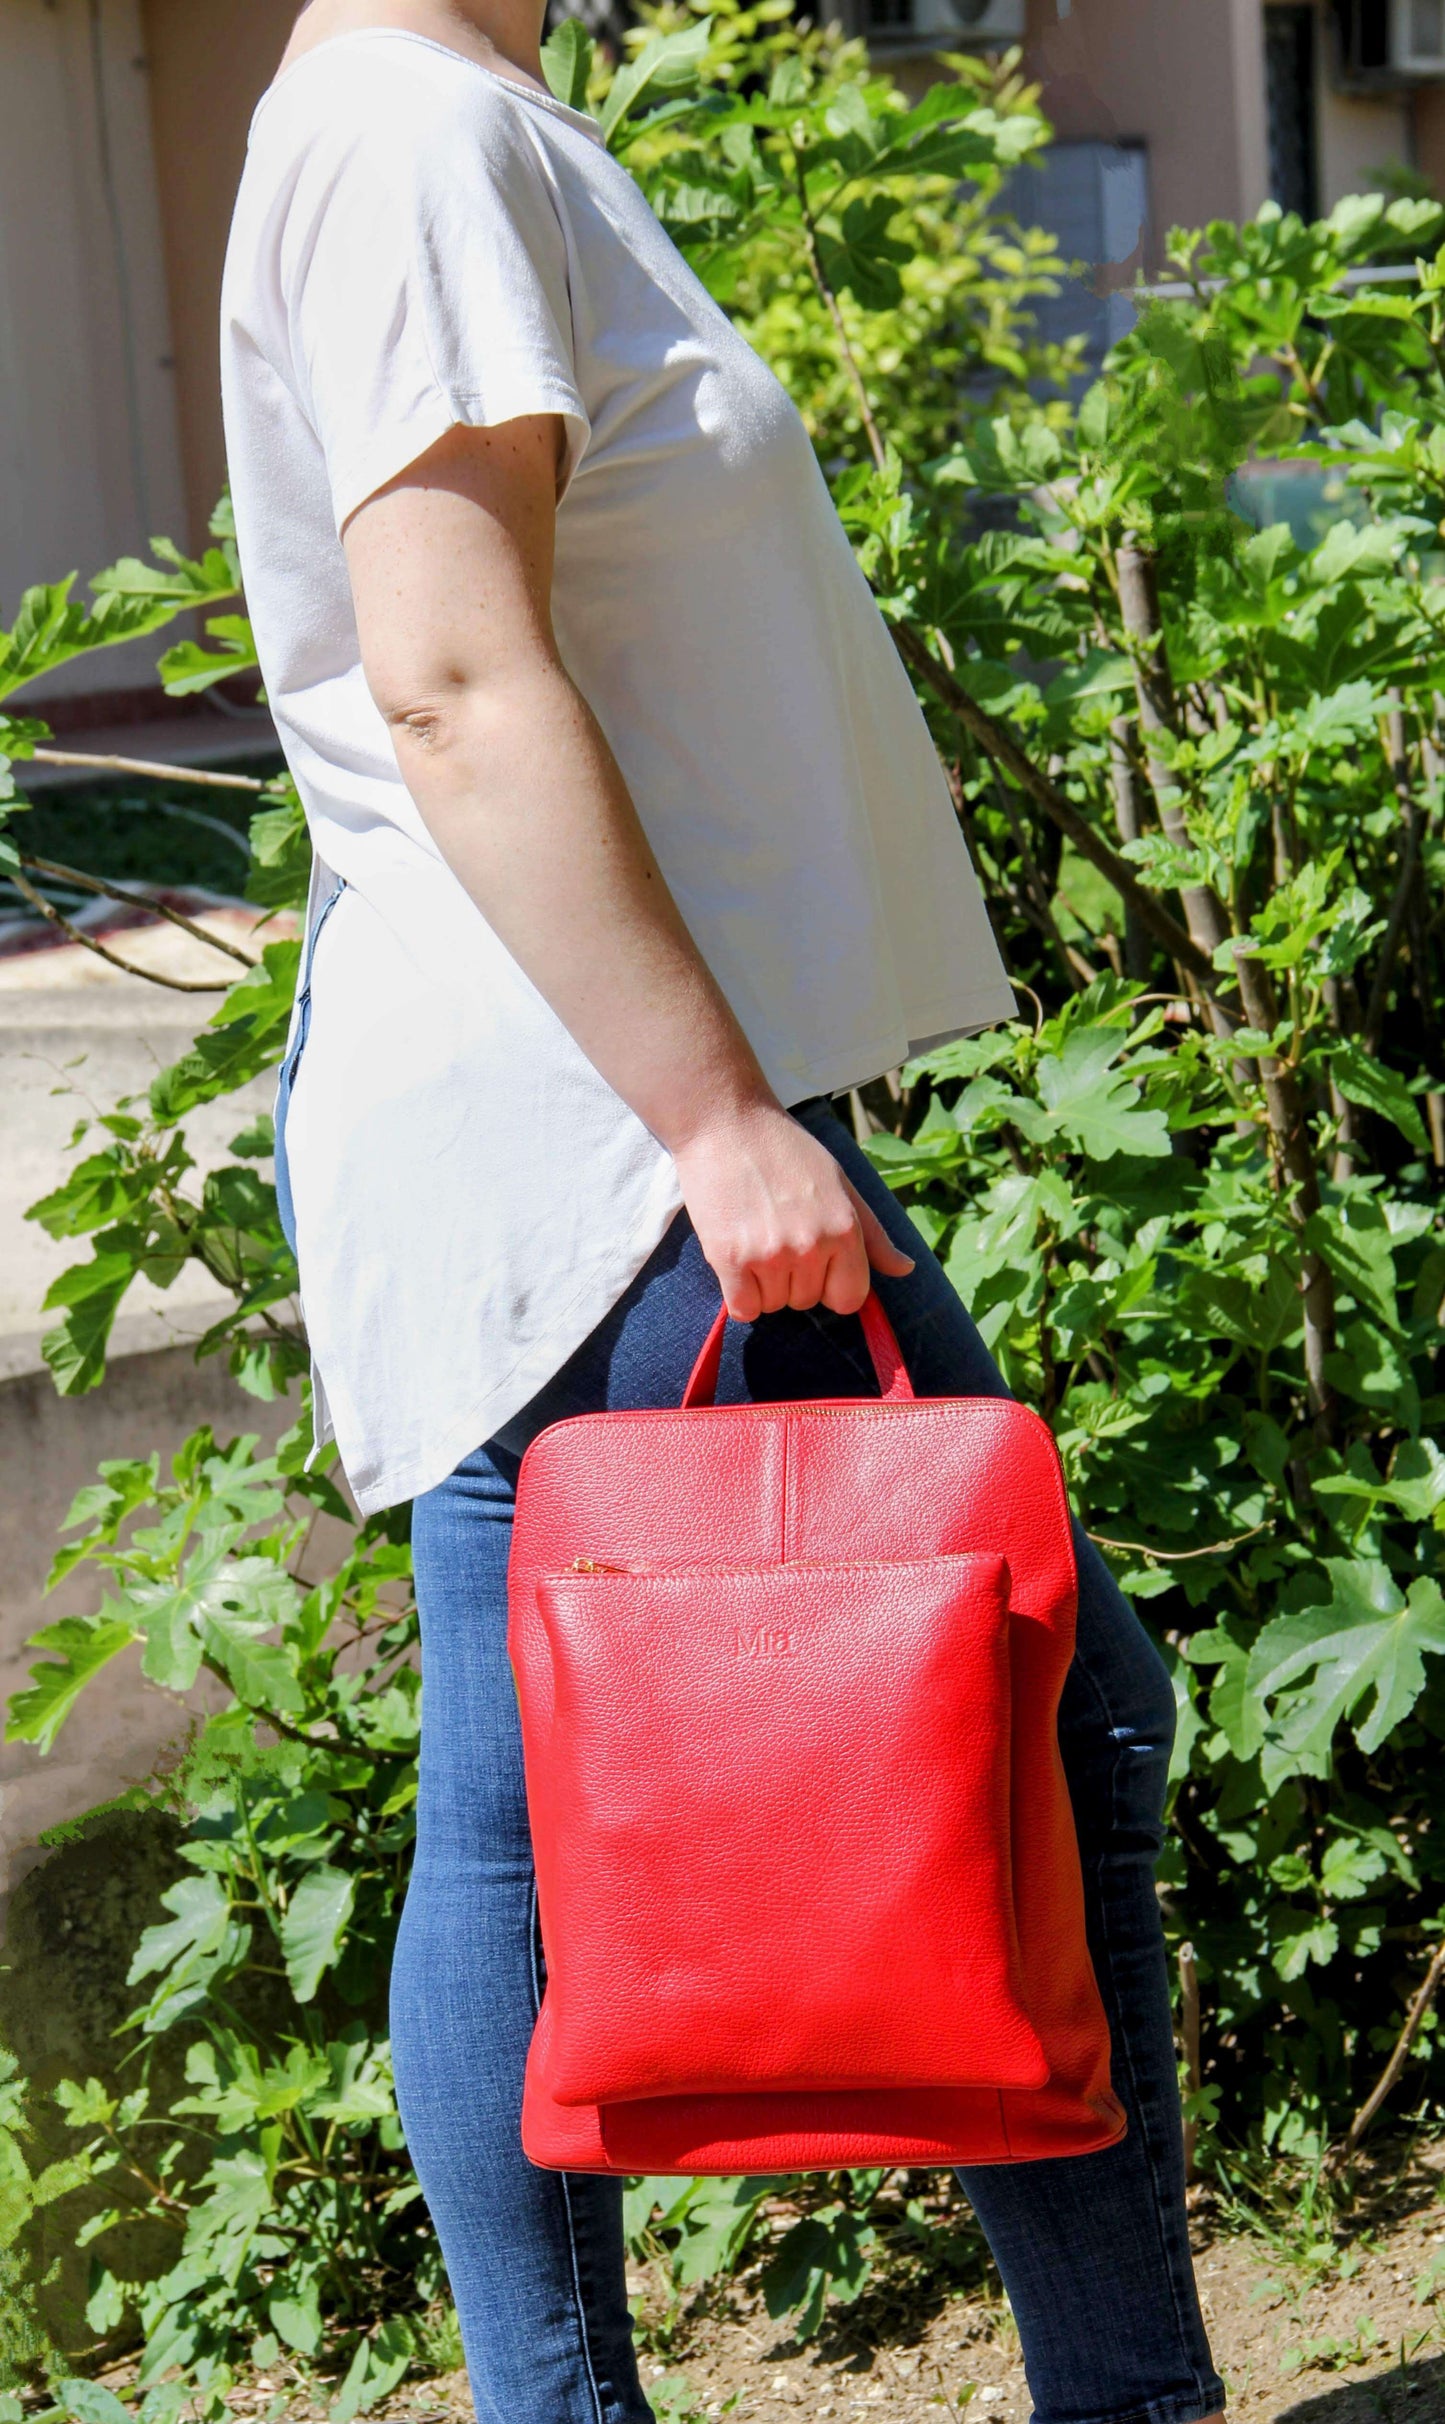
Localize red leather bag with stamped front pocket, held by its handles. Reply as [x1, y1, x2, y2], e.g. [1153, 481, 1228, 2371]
[509, 1297, 1125, 2174]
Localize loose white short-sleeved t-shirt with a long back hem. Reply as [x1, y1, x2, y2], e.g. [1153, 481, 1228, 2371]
[221, 29, 1013, 1513]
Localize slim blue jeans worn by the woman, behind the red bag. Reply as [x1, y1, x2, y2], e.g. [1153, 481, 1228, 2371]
[390, 1100, 1224, 2424]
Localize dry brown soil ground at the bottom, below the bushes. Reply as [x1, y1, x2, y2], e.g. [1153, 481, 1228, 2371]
[107, 2145, 1445, 2424]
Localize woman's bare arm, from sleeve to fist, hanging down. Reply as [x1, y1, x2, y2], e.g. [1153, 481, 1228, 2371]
[344, 415, 912, 1321]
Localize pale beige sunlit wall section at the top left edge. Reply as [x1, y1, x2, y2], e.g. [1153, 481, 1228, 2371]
[0, 0, 182, 698]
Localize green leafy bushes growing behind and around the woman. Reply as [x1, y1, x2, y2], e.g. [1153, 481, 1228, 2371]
[0, 7, 1445, 2385]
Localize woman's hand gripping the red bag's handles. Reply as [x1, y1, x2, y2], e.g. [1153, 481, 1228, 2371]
[672, 1100, 914, 1321]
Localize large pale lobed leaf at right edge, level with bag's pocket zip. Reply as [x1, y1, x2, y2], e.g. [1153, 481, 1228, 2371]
[1249, 1559, 1445, 1774]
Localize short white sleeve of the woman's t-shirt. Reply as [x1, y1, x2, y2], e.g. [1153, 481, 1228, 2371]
[281, 95, 589, 533]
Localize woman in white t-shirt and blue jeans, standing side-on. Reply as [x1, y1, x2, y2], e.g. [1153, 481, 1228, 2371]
[223, 0, 1222, 2424]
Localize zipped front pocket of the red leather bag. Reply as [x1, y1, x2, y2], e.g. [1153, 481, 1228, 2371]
[529, 1556, 1047, 2104]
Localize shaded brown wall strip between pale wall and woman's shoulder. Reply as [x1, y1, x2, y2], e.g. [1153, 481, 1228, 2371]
[143, 0, 298, 545]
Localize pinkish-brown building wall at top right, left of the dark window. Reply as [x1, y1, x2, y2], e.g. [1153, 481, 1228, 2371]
[1026, 0, 1268, 269]
